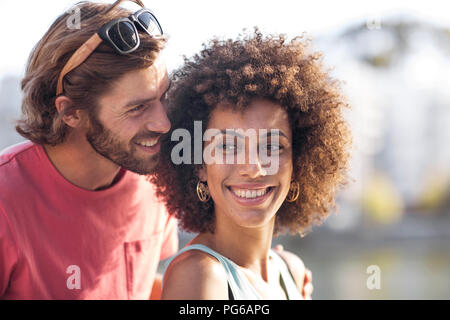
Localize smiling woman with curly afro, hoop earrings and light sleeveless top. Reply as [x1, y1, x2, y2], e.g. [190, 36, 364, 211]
[152, 30, 350, 299]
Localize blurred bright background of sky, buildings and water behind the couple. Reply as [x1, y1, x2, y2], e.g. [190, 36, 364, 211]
[0, 0, 450, 299]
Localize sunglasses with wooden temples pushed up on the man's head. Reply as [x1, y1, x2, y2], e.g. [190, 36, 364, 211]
[56, 0, 163, 96]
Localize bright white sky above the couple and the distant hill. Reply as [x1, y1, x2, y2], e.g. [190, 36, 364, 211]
[0, 0, 450, 78]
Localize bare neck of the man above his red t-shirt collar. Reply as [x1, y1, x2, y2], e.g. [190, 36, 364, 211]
[44, 136, 120, 191]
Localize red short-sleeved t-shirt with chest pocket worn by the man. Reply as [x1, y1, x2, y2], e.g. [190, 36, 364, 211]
[0, 142, 178, 299]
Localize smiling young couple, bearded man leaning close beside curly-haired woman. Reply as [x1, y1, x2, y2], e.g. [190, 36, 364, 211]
[0, 1, 350, 299]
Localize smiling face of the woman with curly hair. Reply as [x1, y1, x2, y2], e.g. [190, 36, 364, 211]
[199, 99, 293, 228]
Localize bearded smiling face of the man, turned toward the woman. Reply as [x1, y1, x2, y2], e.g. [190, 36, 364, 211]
[86, 58, 170, 174]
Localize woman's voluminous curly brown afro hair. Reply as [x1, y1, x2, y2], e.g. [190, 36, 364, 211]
[151, 28, 351, 234]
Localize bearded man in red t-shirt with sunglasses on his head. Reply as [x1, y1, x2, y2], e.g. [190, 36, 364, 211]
[0, 1, 178, 299]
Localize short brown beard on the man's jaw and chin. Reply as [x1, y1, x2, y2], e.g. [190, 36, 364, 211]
[86, 111, 160, 175]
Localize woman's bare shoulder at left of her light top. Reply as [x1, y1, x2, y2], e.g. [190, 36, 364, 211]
[162, 250, 228, 300]
